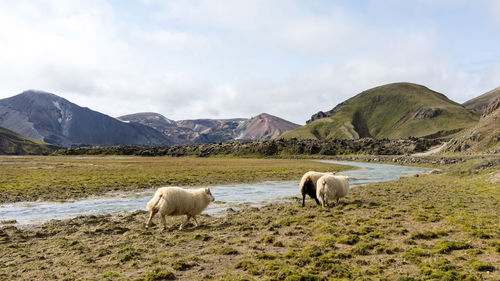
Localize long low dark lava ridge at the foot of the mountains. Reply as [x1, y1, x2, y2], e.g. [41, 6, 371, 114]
[54, 138, 441, 157]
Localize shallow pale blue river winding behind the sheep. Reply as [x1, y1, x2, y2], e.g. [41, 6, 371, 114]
[0, 161, 433, 225]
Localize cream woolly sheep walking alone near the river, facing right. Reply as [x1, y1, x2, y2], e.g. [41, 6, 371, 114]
[146, 186, 215, 230]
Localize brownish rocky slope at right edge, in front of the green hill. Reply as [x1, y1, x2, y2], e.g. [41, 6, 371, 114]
[446, 97, 500, 153]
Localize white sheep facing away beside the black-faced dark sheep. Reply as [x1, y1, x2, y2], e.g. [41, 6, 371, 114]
[316, 175, 349, 207]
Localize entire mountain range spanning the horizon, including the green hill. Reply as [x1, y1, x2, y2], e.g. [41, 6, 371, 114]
[0, 83, 500, 154]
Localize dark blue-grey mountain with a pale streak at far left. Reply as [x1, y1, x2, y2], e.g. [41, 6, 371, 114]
[0, 90, 172, 146]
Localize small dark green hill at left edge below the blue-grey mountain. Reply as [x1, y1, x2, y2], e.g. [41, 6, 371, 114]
[0, 127, 58, 155]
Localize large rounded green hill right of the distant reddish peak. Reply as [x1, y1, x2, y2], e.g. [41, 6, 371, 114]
[282, 83, 479, 139]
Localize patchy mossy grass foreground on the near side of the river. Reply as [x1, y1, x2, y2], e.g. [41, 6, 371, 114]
[0, 155, 500, 280]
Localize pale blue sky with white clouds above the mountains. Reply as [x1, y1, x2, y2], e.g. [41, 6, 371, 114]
[0, 0, 500, 124]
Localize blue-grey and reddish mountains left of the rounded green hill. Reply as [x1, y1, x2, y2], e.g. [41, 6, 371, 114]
[0, 90, 299, 147]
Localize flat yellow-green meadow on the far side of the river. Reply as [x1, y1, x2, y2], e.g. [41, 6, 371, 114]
[0, 156, 347, 202]
